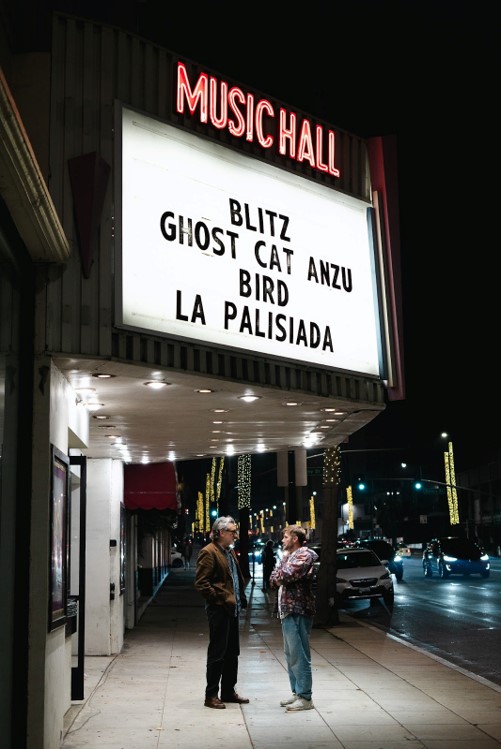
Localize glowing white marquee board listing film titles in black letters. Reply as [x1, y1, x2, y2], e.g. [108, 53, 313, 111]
[117, 107, 381, 376]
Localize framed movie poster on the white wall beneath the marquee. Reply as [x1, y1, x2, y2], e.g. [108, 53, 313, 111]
[49, 445, 69, 631]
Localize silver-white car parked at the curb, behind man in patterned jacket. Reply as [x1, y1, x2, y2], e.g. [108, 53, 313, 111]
[336, 548, 394, 608]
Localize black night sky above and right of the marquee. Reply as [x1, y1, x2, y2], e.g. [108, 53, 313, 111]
[30, 0, 501, 471]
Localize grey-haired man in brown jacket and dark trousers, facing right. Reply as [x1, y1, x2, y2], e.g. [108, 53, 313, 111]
[195, 516, 249, 710]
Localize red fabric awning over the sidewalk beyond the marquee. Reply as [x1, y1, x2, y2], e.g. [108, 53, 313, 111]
[124, 463, 178, 510]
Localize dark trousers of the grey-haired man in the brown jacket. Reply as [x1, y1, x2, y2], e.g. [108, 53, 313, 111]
[205, 606, 240, 698]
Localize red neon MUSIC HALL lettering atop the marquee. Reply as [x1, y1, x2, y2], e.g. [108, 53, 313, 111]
[176, 62, 339, 177]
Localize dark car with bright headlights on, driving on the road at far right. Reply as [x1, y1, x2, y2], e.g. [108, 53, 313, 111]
[423, 536, 491, 580]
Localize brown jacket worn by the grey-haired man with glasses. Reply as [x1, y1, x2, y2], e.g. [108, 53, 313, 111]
[195, 541, 247, 616]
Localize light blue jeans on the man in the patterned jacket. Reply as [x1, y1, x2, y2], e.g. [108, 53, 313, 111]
[282, 614, 313, 700]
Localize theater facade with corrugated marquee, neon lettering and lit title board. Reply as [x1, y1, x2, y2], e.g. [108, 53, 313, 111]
[0, 7, 404, 749]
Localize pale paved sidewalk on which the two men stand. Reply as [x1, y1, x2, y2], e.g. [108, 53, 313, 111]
[62, 566, 501, 749]
